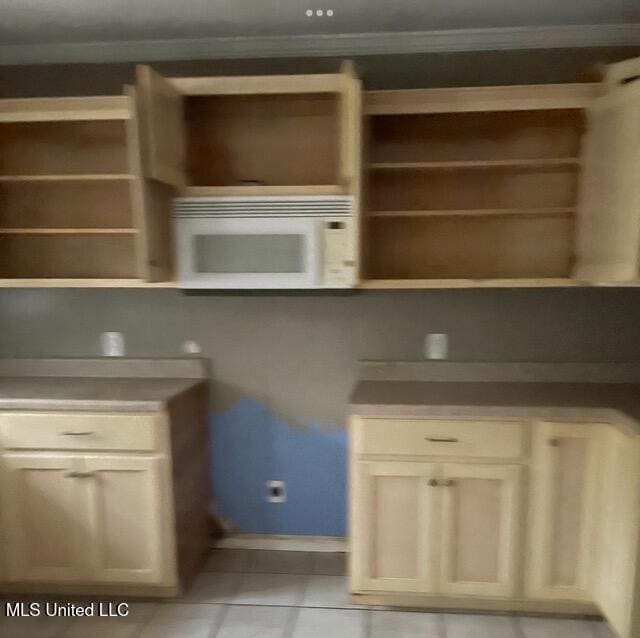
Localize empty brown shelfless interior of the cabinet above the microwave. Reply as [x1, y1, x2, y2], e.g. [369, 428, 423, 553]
[185, 93, 340, 188]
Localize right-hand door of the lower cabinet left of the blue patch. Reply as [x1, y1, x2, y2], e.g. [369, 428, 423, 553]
[86, 455, 173, 584]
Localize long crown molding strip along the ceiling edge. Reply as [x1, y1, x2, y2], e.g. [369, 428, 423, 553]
[0, 23, 640, 66]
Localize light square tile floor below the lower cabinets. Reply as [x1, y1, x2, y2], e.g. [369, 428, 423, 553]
[0, 549, 613, 638]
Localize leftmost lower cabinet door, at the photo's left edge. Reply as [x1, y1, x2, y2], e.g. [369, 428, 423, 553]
[2, 454, 89, 582]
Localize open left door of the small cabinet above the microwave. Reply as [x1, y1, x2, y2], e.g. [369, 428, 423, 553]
[136, 65, 186, 189]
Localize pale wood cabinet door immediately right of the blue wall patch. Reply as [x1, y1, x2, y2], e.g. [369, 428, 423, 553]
[351, 461, 440, 592]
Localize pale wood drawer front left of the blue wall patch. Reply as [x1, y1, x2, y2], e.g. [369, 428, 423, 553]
[0, 412, 160, 452]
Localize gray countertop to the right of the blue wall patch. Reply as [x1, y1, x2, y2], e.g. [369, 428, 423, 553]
[350, 364, 640, 435]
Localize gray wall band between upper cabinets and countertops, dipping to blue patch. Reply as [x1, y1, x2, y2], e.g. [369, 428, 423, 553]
[0, 289, 640, 424]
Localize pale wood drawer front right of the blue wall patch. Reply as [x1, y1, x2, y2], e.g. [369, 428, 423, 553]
[356, 419, 525, 459]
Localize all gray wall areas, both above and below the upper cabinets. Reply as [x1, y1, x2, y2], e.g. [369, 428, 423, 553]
[0, 49, 640, 424]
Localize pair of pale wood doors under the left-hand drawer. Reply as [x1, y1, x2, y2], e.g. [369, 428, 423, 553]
[3, 453, 173, 584]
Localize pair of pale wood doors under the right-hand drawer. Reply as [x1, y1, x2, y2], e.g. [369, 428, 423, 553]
[352, 461, 521, 597]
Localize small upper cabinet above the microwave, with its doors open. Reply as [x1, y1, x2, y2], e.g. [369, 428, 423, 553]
[137, 62, 361, 197]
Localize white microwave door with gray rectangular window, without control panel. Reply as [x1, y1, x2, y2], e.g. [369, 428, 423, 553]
[177, 217, 320, 289]
